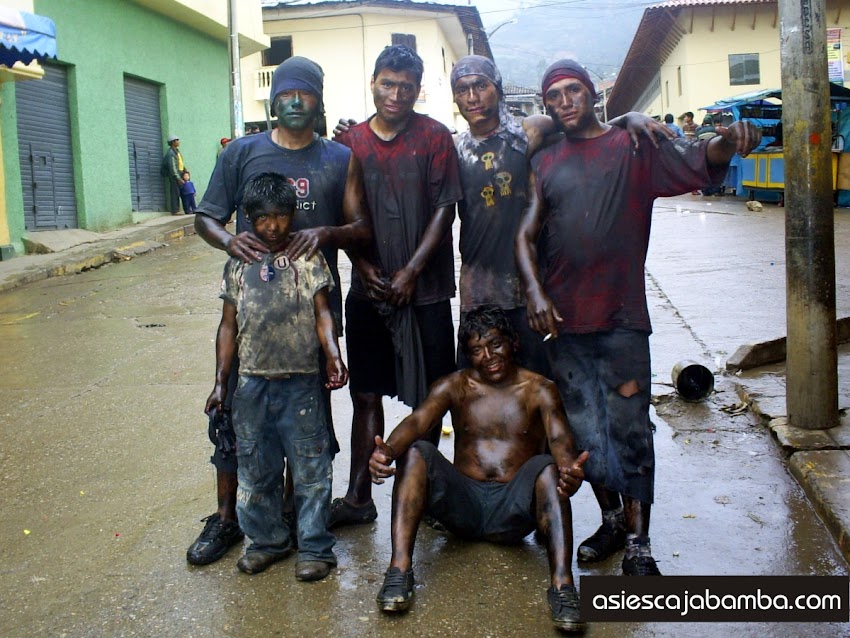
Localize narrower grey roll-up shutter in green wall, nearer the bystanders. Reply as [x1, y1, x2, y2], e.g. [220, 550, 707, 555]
[124, 78, 165, 211]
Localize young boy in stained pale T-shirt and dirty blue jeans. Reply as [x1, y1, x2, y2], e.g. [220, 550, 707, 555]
[205, 173, 348, 581]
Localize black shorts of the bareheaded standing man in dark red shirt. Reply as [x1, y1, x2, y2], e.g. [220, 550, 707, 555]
[345, 294, 456, 397]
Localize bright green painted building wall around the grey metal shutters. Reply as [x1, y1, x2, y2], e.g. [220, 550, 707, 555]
[0, 0, 230, 249]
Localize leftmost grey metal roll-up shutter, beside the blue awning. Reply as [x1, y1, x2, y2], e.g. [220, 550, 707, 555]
[15, 64, 77, 231]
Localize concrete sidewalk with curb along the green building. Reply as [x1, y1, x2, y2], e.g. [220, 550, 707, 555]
[0, 216, 195, 292]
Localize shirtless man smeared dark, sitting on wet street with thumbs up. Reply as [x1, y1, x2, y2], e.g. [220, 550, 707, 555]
[369, 307, 587, 632]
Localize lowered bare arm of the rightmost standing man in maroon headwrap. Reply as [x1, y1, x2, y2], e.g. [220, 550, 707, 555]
[514, 172, 562, 337]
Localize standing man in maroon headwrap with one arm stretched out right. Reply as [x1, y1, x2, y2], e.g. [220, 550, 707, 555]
[516, 60, 761, 576]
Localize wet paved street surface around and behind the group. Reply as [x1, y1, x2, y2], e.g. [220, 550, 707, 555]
[0, 198, 850, 638]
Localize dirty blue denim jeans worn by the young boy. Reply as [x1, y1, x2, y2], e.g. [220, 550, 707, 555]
[233, 374, 336, 565]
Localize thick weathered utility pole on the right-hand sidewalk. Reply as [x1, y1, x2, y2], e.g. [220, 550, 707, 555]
[779, 0, 838, 429]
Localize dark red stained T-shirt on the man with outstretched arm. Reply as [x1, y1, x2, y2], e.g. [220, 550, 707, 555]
[532, 127, 726, 333]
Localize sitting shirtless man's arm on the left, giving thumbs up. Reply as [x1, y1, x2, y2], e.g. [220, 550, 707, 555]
[369, 372, 454, 485]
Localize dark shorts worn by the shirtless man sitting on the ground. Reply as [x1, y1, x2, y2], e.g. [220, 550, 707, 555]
[413, 441, 555, 543]
